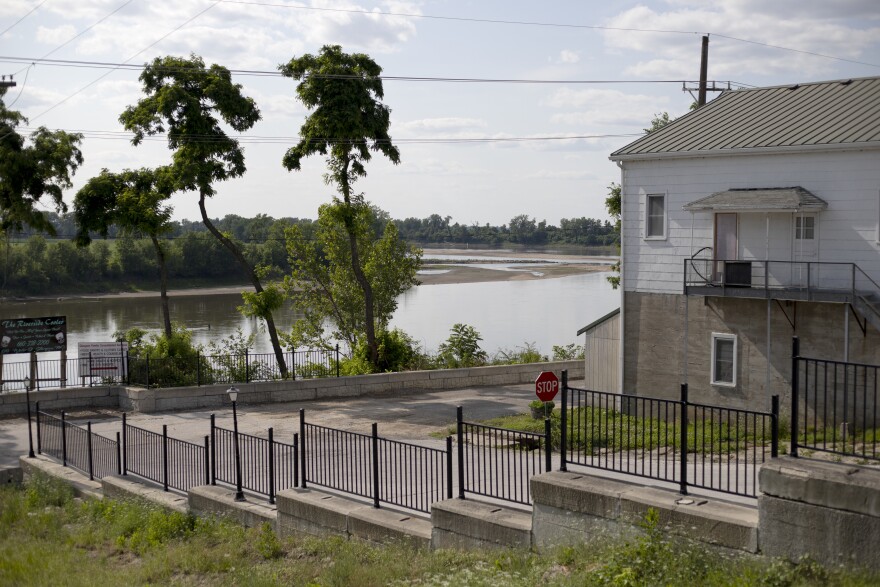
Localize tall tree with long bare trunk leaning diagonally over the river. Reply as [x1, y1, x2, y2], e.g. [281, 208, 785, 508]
[119, 55, 287, 377]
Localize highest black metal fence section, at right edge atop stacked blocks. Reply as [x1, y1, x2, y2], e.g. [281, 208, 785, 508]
[790, 337, 880, 460]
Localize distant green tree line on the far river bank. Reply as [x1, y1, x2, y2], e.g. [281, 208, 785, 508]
[0, 209, 618, 295]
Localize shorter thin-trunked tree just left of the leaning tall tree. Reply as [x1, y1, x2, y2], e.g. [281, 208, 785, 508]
[73, 168, 173, 340]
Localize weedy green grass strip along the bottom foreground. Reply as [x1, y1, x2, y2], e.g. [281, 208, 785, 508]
[0, 477, 880, 587]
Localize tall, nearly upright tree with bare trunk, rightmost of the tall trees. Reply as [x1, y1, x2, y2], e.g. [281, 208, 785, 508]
[279, 45, 400, 366]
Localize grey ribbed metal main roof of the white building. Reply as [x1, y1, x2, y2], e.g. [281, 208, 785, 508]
[611, 77, 880, 161]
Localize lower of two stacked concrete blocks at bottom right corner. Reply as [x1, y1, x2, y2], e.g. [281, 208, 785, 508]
[758, 495, 880, 571]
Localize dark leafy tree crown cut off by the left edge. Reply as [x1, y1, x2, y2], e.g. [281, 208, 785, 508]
[0, 87, 83, 235]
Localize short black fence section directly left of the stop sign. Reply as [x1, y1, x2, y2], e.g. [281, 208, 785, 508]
[456, 406, 552, 504]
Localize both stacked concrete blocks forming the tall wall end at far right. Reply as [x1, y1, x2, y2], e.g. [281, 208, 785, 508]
[758, 457, 880, 571]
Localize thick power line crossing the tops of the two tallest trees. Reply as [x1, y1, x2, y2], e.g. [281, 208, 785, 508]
[0, 55, 749, 87]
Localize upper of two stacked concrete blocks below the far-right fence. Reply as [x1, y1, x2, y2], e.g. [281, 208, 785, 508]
[760, 457, 880, 517]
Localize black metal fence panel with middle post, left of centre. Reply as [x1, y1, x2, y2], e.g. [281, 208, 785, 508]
[299, 410, 452, 512]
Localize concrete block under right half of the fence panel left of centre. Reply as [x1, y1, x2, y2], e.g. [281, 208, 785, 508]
[348, 506, 431, 549]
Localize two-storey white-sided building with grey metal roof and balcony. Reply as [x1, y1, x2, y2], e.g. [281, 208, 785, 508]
[611, 77, 880, 409]
